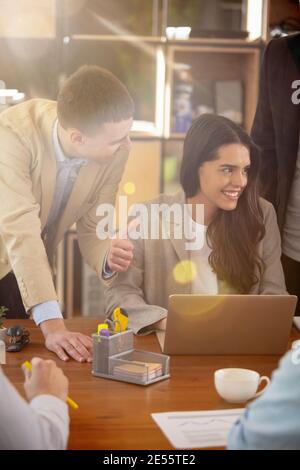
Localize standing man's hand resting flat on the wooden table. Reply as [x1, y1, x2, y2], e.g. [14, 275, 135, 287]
[40, 319, 92, 362]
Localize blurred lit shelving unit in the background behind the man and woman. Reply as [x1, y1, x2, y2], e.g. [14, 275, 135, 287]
[0, 0, 275, 316]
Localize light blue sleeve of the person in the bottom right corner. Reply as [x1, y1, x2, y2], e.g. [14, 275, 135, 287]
[228, 341, 300, 450]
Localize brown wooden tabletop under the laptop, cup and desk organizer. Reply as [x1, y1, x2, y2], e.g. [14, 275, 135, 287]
[4, 318, 300, 450]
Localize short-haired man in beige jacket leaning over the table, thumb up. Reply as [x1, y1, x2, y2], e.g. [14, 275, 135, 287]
[0, 66, 134, 361]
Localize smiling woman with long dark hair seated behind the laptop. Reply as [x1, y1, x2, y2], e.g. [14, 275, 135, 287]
[105, 114, 286, 334]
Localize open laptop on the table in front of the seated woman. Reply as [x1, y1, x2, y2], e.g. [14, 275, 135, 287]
[158, 294, 297, 355]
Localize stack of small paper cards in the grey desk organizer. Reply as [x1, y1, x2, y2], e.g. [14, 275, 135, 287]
[113, 361, 163, 382]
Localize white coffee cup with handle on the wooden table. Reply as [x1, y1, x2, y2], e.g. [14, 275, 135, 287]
[215, 368, 270, 403]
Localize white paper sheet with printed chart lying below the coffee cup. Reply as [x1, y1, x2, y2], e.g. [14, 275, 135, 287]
[151, 408, 244, 449]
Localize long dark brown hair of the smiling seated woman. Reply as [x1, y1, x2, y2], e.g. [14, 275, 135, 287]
[180, 114, 265, 294]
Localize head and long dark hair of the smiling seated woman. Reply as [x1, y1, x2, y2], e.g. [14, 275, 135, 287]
[180, 114, 265, 293]
